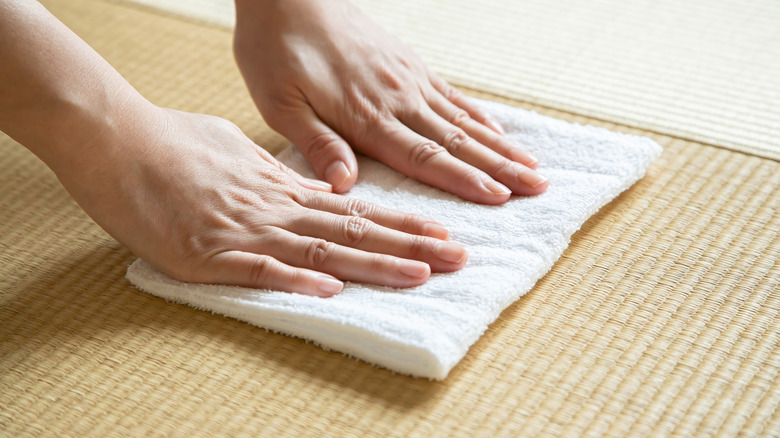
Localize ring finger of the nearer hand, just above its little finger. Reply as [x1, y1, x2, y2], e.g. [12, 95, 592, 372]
[264, 228, 431, 288]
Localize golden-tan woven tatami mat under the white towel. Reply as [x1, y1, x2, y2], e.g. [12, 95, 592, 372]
[0, 0, 780, 437]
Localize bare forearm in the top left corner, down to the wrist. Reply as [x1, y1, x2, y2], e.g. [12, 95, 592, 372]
[0, 0, 157, 179]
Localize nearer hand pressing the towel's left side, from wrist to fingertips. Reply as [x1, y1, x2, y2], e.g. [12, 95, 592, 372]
[59, 107, 466, 296]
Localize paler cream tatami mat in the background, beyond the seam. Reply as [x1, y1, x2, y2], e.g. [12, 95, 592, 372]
[117, 0, 780, 163]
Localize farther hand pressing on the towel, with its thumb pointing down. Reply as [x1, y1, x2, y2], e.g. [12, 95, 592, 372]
[234, 0, 547, 204]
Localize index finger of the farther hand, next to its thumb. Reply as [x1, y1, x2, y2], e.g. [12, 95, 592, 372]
[366, 120, 512, 205]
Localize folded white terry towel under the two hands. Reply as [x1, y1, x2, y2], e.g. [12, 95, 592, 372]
[127, 102, 661, 379]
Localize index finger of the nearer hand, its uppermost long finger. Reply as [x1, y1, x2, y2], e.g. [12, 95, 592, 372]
[298, 193, 450, 240]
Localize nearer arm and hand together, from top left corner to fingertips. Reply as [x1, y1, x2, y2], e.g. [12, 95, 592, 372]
[0, 0, 466, 297]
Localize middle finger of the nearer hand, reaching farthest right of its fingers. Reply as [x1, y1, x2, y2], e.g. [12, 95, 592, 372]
[288, 210, 467, 272]
